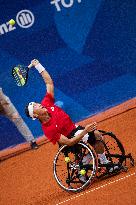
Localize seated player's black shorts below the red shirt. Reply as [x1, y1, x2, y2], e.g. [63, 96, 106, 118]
[67, 125, 96, 145]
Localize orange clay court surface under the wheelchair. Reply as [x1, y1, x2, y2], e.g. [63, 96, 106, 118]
[0, 100, 136, 205]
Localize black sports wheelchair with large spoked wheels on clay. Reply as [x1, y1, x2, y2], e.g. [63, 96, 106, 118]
[53, 130, 134, 192]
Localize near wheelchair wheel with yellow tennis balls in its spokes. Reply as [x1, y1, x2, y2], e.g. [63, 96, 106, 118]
[53, 142, 98, 192]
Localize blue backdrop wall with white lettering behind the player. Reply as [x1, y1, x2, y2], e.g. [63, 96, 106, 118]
[0, 0, 136, 149]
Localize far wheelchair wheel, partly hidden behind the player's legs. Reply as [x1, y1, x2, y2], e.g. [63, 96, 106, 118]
[99, 130, 125, 165]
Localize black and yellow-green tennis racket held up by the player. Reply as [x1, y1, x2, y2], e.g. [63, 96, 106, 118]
[12, 64, 33, 86]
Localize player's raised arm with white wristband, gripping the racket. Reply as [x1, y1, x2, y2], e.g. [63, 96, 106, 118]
[31, 59, 54, 97]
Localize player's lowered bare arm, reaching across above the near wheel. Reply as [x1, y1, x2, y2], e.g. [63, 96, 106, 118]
[58, 122, 97, 146]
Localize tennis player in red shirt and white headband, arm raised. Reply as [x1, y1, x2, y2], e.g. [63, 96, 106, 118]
[25, 59, 117, 180]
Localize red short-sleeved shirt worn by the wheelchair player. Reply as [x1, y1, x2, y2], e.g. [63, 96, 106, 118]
[41, 93, 76, 144]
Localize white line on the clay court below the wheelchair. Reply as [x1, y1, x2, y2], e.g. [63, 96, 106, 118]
[56, 172, 136, 205]
